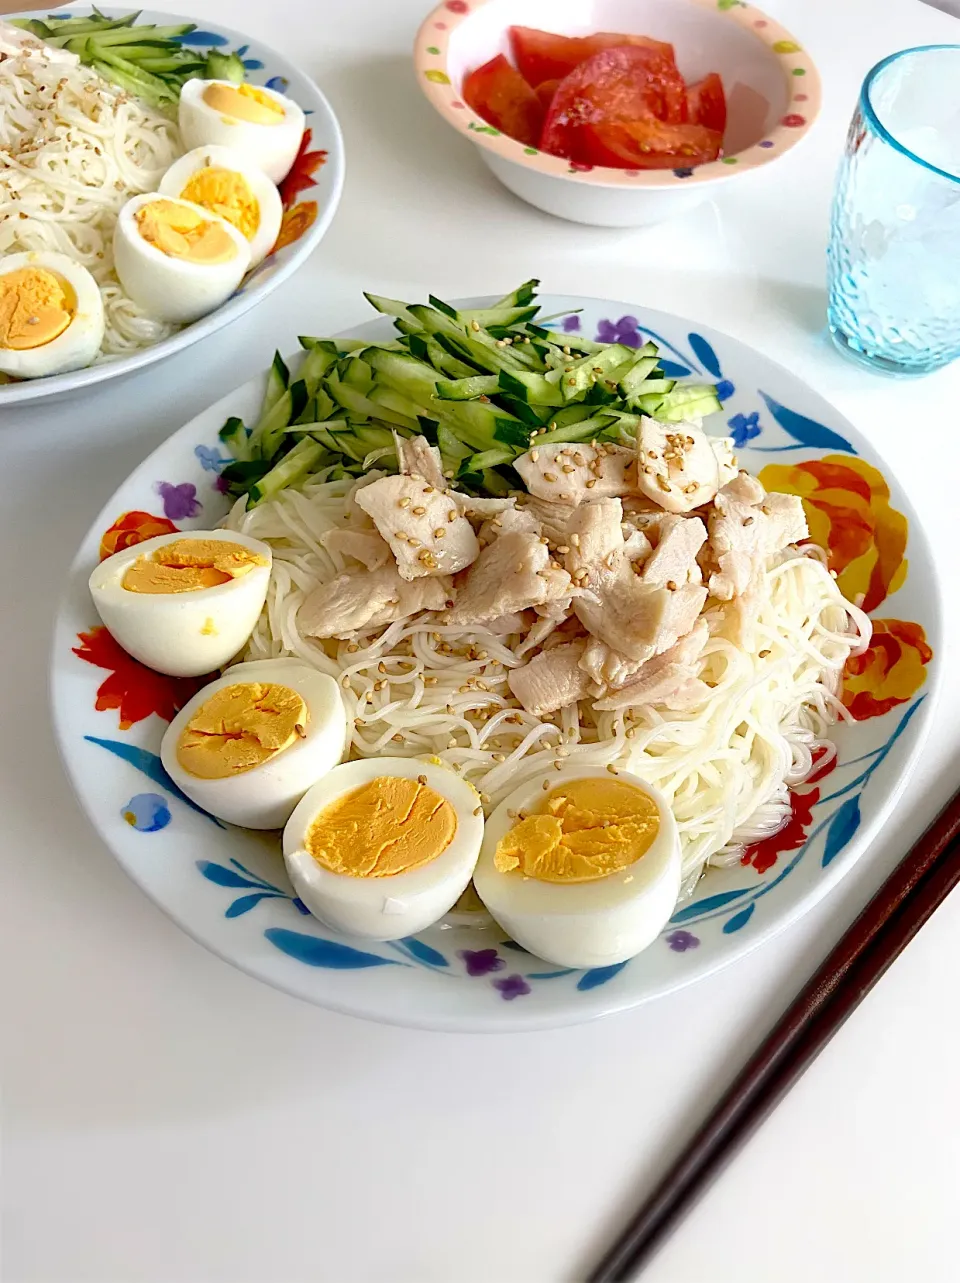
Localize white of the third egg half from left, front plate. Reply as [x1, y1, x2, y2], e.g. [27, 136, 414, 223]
[284, 757, 484, 940]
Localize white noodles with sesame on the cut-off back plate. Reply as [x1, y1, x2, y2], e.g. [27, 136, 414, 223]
[0, 58, 184, 359]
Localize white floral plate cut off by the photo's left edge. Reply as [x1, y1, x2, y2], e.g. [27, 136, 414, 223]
[0, 4, 344, 405]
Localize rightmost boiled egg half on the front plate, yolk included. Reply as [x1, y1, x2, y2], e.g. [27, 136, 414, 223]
[474, 766, 680, 967]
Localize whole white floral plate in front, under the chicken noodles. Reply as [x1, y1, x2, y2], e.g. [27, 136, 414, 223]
[51, 298, 942, 1030]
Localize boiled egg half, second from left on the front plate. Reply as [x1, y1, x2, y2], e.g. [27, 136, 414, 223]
[160, 659, 347, 829]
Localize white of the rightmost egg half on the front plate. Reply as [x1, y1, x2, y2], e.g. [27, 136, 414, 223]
[474, 766, 680, 967]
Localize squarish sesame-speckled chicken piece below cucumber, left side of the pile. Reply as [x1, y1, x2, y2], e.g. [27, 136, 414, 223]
[356, 476, 480, 580]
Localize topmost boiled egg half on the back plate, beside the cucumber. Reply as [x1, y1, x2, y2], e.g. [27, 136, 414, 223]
[180, 80, 305, 182]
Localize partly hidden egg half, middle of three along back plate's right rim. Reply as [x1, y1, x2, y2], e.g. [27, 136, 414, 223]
[160, 144, 284, 267]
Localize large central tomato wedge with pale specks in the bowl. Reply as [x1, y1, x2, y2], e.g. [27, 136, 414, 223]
[540, 45, 687, 160]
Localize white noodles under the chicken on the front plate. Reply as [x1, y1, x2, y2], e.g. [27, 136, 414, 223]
[227, 479, 870, 892]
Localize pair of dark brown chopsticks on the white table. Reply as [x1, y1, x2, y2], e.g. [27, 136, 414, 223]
[587, 793, 960, 1283]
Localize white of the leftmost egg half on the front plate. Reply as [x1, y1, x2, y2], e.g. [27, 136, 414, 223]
[90, 530, 273, 677]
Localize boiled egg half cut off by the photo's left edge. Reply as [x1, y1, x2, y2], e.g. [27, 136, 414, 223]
[0, 250, 104, 378]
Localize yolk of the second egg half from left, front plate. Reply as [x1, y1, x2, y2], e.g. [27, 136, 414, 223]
[177, 681, 309, 780]
